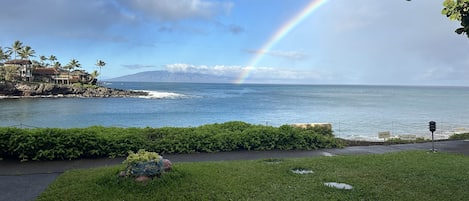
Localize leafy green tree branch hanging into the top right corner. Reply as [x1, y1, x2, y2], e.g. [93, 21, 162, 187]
[441, 0, 469, 37]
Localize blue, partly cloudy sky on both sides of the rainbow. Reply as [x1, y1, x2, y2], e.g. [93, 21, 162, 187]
[0, 0, 469, 86]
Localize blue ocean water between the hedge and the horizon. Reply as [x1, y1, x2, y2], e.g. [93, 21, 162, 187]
[0, 82, 469, 140]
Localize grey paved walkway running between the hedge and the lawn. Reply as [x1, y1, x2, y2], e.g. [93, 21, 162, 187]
[0, 141, 469, 201]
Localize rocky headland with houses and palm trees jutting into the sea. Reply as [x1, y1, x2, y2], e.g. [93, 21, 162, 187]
[0, 41, 148, 98]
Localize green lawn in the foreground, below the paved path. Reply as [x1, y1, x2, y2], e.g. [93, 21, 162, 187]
[38, 151, 469, 201]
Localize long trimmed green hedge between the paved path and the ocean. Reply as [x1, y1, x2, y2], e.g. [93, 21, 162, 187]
[0, 121, 341, 160]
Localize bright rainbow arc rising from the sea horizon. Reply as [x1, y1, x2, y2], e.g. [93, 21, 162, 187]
[235, 0, 327, 84]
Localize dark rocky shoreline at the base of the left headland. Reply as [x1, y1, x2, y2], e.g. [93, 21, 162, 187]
[0, 82, 149, 98]
